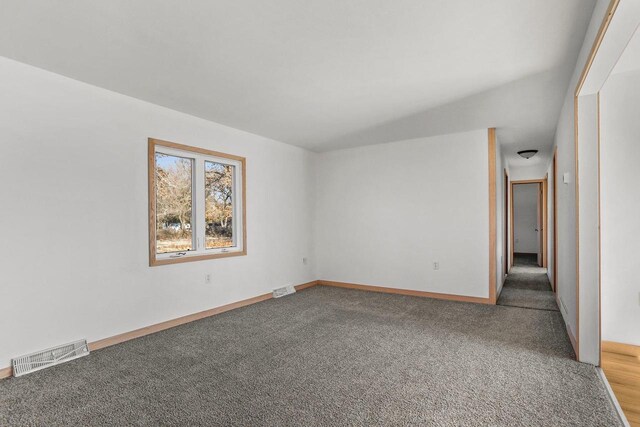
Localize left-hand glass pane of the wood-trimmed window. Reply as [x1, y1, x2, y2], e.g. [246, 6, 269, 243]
[156, 153, 193, 254]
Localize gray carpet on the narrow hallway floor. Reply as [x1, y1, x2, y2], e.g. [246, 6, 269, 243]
[498, 255, 559, 311]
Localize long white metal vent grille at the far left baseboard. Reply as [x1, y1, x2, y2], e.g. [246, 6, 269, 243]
[11, 340, 89, 377]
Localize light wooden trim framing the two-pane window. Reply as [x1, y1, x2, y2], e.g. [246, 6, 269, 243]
[147, 138, 247, 267]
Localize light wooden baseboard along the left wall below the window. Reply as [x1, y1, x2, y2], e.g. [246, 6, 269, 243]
[0, 280, 318, 379]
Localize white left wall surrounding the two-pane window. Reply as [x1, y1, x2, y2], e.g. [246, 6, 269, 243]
[0, 58, 316, 367]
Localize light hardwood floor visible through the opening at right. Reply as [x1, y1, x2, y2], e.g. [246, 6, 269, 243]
[602, 341, 640, 427]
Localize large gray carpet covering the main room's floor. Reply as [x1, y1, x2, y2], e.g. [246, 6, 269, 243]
[0, 287, 619, 426]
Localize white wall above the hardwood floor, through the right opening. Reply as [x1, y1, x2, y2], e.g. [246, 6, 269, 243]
[600, 71, 640, 345]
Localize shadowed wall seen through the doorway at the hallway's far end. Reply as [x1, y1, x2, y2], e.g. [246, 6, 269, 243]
[513, 184, 540, 254]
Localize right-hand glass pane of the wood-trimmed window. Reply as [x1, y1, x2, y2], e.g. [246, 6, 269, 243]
[204, 161, 234, 249]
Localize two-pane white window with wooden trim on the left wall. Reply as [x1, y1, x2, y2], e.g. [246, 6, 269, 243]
[149, 139, 246, 266]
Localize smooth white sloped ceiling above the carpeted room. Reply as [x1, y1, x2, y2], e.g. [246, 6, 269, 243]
[0, 0, 595, 165]
